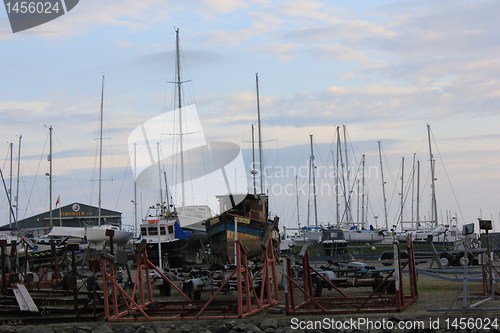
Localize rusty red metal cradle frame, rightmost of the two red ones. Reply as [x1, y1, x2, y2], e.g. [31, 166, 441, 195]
[285, 235, 418, 315]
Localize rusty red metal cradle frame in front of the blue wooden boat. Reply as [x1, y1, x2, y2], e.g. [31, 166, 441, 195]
[102, 238, 279, 322]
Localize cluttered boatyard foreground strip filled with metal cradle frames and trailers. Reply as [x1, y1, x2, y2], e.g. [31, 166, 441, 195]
[0, 219, 500, 326]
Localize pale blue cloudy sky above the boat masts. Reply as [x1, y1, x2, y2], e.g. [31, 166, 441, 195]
[0, 0, 500, 230]
